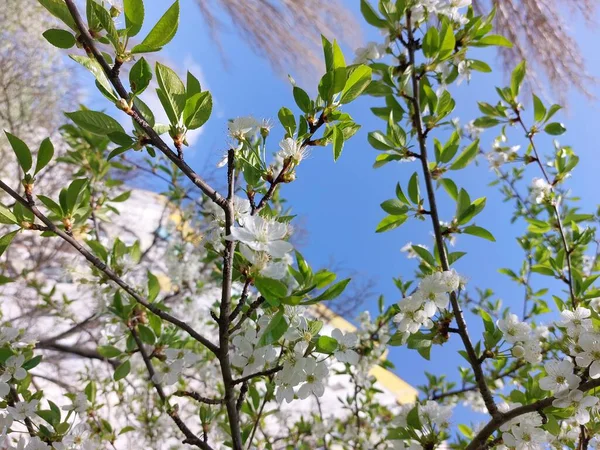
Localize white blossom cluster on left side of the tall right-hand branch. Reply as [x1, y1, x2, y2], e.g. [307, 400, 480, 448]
[394, 270, 460, 336]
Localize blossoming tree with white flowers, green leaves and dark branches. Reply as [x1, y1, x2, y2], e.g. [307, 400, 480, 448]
[0, 0, 600, 450]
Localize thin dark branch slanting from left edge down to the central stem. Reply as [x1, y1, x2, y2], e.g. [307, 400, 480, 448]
[0, 180, 219, 354]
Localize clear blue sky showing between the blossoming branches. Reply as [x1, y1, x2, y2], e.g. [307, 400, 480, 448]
[86, 0, 600, 422]
